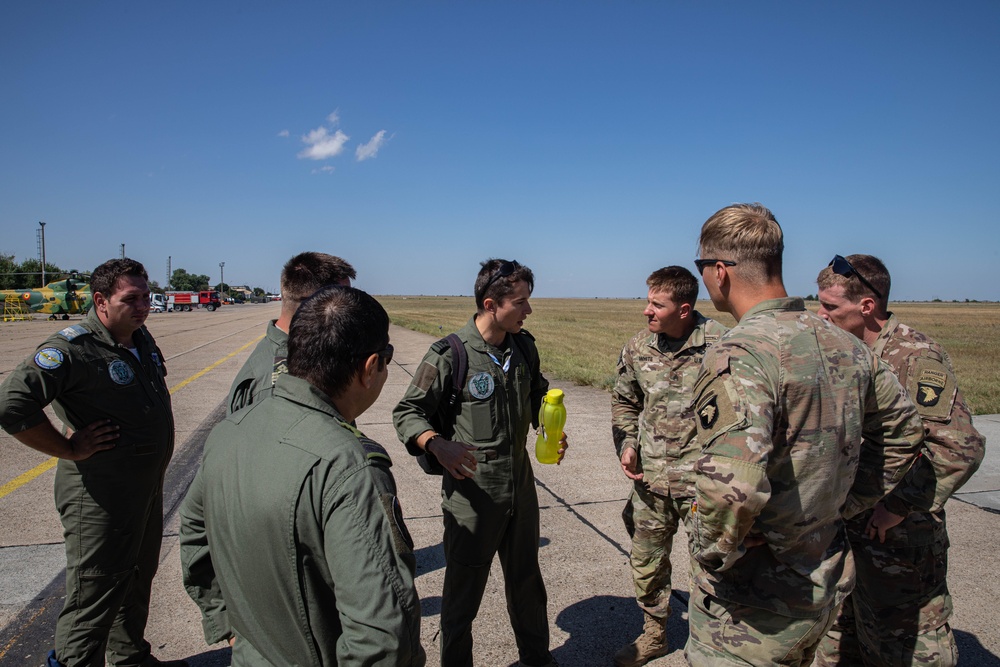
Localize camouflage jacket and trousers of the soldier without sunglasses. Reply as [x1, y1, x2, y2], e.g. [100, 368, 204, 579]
[611, 311, 728, 619]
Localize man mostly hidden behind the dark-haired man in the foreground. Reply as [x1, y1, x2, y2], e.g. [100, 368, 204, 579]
[229, 252, 357, 414]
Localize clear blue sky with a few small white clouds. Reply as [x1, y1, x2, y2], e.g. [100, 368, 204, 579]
[0, 0, 1000, 300]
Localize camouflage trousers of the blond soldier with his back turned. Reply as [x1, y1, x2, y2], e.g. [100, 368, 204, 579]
[684, 586, 836, 667]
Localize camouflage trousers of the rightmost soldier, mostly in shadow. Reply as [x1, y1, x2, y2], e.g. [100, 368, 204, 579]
[816, 511, 958, 667]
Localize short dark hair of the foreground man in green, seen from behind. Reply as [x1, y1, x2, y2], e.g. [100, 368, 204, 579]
[288, 285, 389, 397]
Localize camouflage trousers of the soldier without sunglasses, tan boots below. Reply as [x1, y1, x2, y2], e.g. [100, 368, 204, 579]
[622, 483, 691, 619]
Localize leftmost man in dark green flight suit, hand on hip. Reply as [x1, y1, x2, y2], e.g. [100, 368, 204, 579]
[0, 258, 187, 667]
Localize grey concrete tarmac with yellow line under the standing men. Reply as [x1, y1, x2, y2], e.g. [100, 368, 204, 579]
[0, 304, 1000, 667]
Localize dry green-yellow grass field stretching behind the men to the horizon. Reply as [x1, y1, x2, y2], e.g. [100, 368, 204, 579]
[378, 296, 1000, 414]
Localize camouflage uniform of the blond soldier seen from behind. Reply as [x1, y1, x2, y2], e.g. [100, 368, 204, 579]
[685, 298, 923, 665]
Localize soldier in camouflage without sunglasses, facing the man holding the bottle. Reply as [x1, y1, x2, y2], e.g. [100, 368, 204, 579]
[611, 266, 727, 667]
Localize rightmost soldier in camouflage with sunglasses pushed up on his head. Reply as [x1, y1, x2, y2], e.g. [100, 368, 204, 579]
[816, 255, 986, 666]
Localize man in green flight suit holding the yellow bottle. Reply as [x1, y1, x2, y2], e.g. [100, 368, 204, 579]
[393, 259, 566, 667]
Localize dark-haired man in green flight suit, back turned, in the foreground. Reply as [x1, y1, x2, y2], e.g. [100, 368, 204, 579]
[180, 286, 426, 667]
